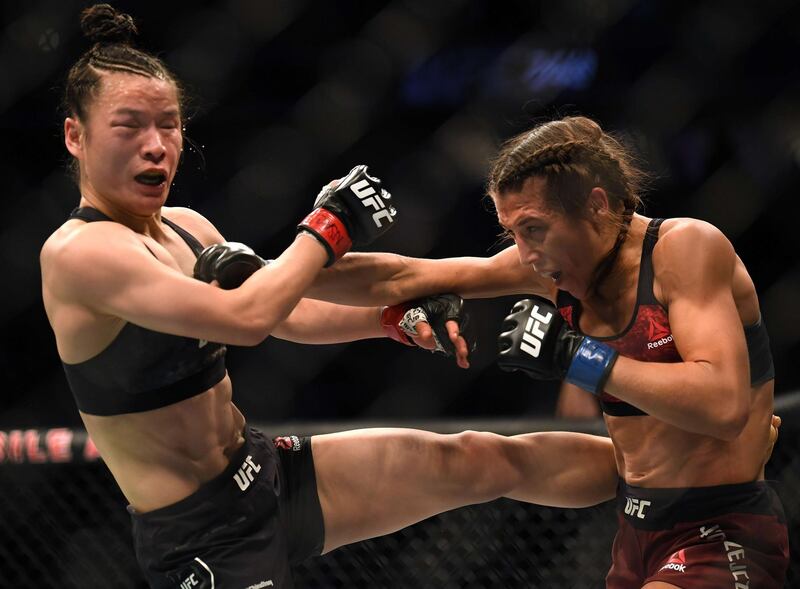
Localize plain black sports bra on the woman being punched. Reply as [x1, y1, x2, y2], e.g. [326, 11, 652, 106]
[63, 207, 225, 415]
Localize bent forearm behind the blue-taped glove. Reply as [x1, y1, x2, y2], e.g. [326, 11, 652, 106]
[605, 356, 750, 439]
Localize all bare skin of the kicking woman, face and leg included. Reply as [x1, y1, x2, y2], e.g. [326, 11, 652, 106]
[40, 72, 617, 551]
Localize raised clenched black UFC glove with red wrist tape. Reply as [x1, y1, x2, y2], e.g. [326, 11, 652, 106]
[297, 165, 396, 267]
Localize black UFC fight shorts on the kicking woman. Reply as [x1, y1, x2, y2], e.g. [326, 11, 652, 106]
[131, 428, 324, 589]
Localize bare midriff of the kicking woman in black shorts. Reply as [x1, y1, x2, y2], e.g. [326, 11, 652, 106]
[81, 375, 245, 512]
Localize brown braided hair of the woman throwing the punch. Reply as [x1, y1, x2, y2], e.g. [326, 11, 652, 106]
[487, 117, 646, 292]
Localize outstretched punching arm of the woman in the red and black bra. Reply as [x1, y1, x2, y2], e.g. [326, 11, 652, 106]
[307, 248, 545, 305]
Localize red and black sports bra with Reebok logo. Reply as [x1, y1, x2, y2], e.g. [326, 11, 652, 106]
[556, 219, 775, 416]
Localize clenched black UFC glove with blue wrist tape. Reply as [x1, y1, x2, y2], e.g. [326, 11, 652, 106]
[497, 299, 618, 395]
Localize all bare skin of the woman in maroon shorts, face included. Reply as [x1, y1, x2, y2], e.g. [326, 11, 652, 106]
[316, 178, 774, 487]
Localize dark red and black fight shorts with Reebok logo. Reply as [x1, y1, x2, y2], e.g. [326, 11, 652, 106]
[606, 481, 789, 589]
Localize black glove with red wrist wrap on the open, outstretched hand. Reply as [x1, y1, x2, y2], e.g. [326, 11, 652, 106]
[381, 294, 476, 357]
